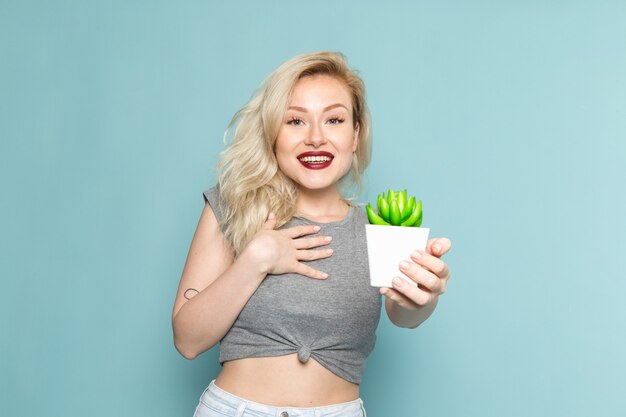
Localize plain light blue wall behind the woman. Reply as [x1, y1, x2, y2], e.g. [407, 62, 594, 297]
[0, 0, 626, 417]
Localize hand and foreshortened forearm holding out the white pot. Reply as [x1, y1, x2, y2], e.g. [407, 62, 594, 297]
[380, 238, 451, 329]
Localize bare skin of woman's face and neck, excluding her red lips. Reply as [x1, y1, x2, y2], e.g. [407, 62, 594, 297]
[274, 75, 359, 219]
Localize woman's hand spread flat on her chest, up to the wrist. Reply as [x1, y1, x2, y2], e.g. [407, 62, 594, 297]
[244, 213, 333, 279]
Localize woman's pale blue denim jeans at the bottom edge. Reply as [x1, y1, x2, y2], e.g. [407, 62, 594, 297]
[193, 380, 366, 417]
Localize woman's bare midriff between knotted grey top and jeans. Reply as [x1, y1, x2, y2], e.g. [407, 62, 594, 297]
[215, 353, 359, 407]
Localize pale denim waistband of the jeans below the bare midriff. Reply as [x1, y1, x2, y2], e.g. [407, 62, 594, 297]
[201, 380, 365, 417]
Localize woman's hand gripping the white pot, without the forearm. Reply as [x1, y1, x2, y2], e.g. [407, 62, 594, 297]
[380, 238, 452, 310]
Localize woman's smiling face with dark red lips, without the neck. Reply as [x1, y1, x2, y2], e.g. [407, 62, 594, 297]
[274, 75, 358, 190]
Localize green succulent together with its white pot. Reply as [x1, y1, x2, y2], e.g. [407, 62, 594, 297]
[365, 189, 430, 288]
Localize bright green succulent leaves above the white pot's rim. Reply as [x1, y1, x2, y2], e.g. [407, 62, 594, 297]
[365, 189, 422, 227]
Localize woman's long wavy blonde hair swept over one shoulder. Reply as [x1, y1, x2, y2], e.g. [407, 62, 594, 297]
[217, 52, 371, 255]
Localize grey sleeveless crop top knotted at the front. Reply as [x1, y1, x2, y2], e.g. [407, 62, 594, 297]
[203, 187, 382, 384]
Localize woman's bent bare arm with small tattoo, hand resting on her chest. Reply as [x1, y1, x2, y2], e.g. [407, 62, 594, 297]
[172, 203, 330, 359]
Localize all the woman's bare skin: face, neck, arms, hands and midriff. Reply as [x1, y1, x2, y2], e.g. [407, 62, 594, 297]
[172, 76, 450, 407]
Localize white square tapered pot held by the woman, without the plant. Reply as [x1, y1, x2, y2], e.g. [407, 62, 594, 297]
[365, 224, 430, 288]
